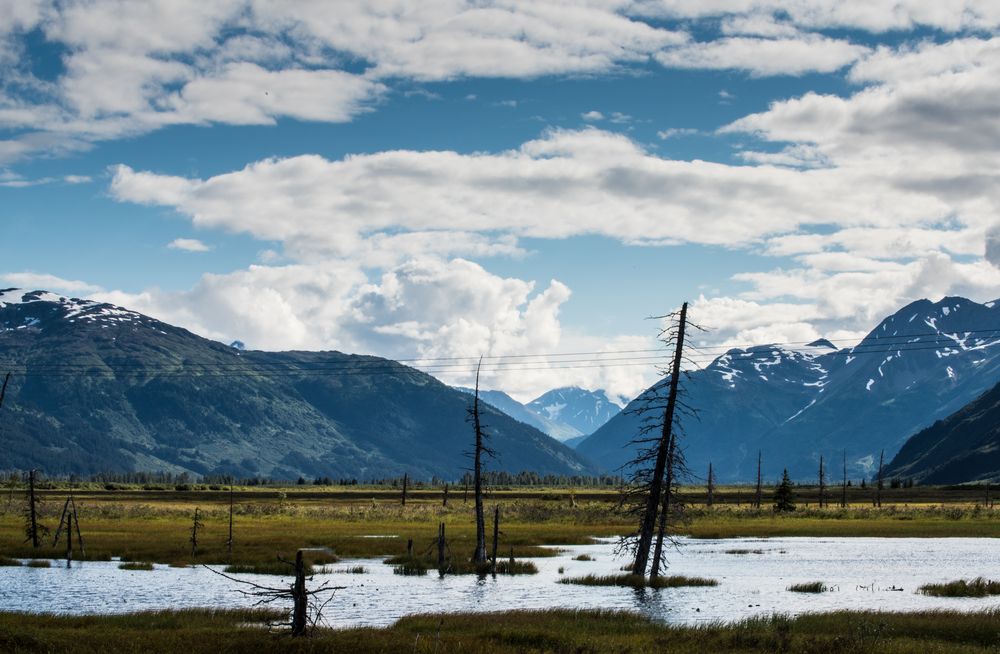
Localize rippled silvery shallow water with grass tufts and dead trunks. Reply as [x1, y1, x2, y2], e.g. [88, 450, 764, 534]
[0, 538, 1000, 627]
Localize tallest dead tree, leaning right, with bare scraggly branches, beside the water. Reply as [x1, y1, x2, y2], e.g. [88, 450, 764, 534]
[623, 302, 687, 576]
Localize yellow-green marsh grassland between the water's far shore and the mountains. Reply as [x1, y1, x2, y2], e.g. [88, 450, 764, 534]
[0, 487, 1000, 566]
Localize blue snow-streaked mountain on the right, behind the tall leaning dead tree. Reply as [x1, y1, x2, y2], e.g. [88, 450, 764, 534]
[578, 297, 1000, 481]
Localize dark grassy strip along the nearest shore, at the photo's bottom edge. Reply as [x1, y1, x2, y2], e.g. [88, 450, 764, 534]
[0, 605, 1000, 654]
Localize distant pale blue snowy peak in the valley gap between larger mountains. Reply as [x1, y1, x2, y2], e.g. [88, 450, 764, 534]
[456, 386, 621, 447]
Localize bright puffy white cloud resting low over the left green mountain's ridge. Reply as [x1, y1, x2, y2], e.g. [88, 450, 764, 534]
[96, 257, 616, 398]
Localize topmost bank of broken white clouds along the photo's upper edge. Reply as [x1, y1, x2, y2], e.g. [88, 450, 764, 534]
[7, 0, 980, 162]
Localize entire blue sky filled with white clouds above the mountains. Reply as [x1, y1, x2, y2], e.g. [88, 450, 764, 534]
[0, 0, 1000, 400]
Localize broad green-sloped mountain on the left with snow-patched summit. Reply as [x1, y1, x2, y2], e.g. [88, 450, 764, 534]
[0, 289, 597, 479]
